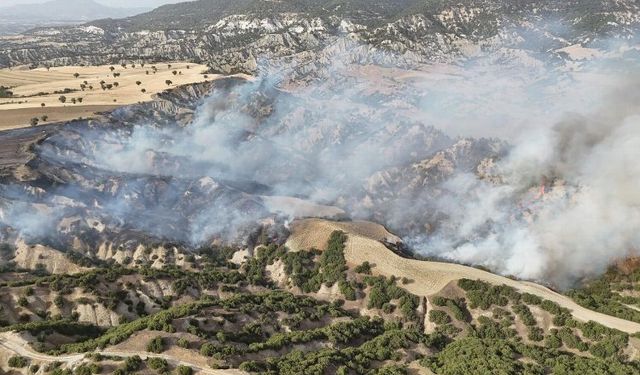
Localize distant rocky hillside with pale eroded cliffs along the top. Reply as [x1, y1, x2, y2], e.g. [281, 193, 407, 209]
[0, 0, 639, 73]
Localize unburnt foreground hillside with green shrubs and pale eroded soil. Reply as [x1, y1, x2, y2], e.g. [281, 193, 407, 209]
[0, 221, 640, 374]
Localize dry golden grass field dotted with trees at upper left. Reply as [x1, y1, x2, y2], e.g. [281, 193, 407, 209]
[0, 63, 242, 129]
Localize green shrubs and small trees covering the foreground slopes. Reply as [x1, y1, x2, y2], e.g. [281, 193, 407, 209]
[0, 232, 640, 375]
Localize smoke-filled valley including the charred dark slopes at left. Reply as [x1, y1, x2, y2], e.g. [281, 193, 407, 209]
[1, 42, 640, 287]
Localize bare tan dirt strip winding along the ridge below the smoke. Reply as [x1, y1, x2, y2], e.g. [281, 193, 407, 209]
[287, 219, 640, 333]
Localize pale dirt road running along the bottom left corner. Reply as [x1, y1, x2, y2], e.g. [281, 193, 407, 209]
[0, 332, 245, 375]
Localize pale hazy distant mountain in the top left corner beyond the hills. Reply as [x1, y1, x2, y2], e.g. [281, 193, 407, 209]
[0, 0, 149, 23]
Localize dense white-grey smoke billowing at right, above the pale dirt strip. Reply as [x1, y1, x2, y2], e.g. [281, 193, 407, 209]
[412, 75, 640, 287]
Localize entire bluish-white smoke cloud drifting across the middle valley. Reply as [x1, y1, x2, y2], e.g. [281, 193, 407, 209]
[4, 37, 640, 287]
